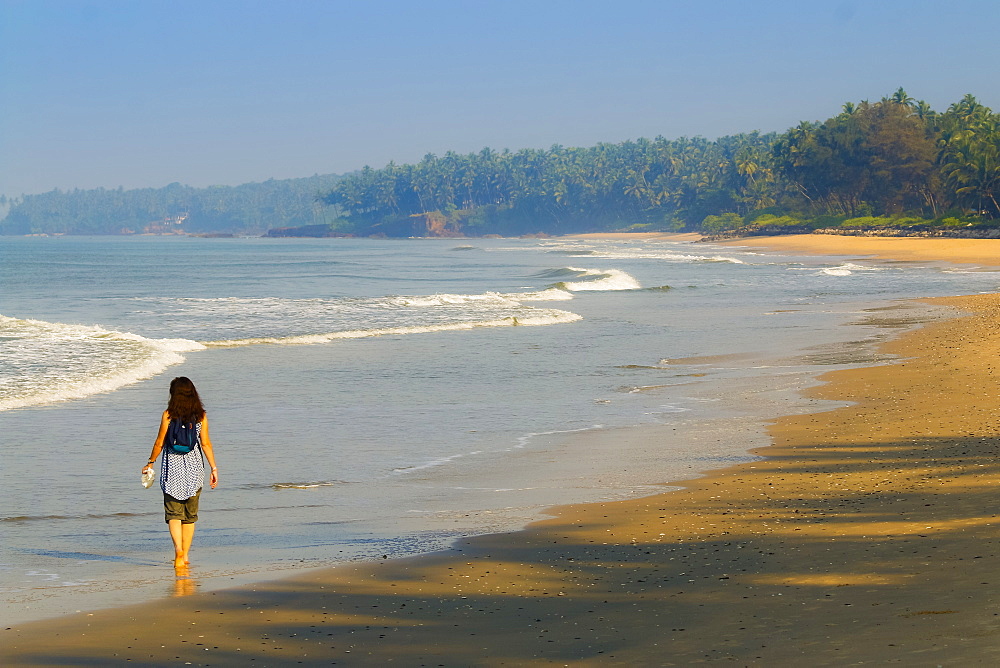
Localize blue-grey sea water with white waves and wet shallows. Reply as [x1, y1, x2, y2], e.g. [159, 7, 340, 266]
[0, 237, 1000, 623]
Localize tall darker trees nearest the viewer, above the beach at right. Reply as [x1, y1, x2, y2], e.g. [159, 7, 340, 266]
[774, 89, 1000, 220]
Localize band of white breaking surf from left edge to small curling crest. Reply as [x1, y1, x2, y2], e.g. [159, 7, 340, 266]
[0, 267, 642, 411]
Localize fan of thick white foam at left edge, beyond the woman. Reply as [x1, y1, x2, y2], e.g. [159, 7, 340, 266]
[0, 316, 205, 411]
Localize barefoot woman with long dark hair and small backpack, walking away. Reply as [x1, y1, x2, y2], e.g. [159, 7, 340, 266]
[142, 376, 219, 568]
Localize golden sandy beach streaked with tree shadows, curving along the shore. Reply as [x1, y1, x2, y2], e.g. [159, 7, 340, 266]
[0, 235, 1000, 666]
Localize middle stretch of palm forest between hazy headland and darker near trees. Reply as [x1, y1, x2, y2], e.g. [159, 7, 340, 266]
[327, 133, 774, 234]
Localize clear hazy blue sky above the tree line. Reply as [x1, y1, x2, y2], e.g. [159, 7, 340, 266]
[0, 0, 1000, 195]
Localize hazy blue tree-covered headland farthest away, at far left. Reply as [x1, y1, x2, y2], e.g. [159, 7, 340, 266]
[0, 175, 340, 235]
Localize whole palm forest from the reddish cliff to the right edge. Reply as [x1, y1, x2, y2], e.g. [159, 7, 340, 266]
[4, 89, 1000, 237]
